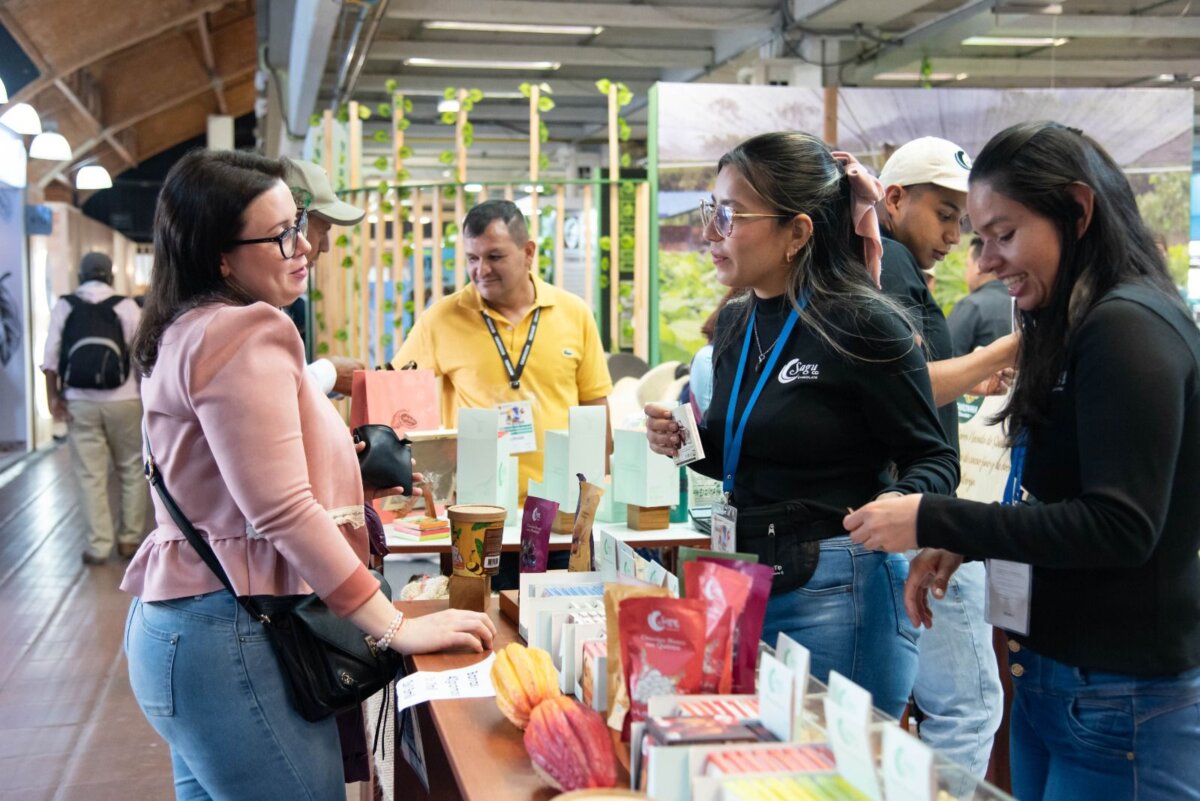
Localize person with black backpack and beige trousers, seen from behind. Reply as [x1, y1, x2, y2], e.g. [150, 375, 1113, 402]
[42, 253, 148, 565]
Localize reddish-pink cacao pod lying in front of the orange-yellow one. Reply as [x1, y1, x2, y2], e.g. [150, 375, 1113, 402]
[524, 695, 617, 790]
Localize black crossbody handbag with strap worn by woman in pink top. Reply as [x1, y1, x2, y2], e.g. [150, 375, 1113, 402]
[143, 438, 402, 722]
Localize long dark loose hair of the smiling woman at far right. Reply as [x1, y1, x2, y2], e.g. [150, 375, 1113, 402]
[971, 122, 1182, 440]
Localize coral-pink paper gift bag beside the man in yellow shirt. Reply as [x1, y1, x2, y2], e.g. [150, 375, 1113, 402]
[350, 369, 442, 436]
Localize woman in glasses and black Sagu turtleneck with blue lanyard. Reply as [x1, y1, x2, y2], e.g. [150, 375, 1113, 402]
[646, 133, 958, 716]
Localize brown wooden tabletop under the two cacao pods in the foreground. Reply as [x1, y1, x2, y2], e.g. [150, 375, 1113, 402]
[389, 601, 629, 801]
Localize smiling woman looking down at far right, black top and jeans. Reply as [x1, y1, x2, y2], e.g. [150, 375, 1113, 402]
[846, 122, 1200, 801]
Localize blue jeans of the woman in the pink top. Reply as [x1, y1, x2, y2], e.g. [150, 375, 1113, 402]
[125, 590, 346, 801]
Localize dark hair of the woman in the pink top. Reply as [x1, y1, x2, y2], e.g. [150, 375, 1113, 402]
[132, 150, 287, 375]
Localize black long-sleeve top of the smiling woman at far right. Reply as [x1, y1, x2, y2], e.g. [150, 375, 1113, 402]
[917, 284, 1200, 675]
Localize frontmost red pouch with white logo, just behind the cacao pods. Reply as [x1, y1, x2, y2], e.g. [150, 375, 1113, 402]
[618, 597, 707, 741]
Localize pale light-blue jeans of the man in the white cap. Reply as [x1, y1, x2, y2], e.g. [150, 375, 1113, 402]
[912, 562, 1004, 796]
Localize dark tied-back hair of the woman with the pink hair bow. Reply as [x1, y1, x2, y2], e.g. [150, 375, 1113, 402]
[714, 132, 912, 360]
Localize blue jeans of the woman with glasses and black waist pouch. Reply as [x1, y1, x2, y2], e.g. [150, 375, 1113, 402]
[762, 537, 918, 717]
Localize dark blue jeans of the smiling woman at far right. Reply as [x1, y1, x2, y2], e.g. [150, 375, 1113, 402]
[1009, 632, 1200, 801]
